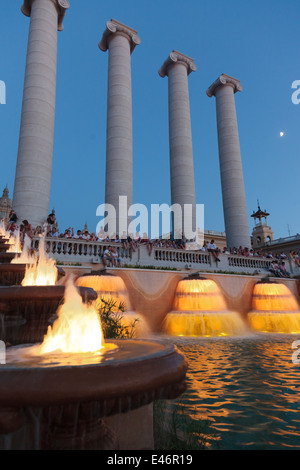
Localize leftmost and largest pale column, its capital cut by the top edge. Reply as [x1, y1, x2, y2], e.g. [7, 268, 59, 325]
[13, 0, 69, 226]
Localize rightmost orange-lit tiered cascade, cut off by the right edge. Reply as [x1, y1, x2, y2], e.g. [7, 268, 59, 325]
[248, 278, 300, 334]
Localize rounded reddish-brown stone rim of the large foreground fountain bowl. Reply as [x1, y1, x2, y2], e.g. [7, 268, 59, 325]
[0, 339, 187, 408]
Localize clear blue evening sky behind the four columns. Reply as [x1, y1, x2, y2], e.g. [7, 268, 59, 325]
[0, 0, 300, 238]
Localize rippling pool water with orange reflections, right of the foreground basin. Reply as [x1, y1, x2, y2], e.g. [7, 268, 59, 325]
[165, 334, 300, 449]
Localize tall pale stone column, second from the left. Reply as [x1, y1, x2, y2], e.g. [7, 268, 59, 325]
[99, 19, 141, 235]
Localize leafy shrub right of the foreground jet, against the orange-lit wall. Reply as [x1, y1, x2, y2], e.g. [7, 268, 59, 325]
[99, 298, 139, 339]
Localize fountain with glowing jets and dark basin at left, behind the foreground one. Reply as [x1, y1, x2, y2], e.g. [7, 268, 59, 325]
[0, 233, 92, 345]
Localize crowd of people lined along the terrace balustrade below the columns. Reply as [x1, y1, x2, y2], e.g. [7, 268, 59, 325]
[7, 210, 300, 268]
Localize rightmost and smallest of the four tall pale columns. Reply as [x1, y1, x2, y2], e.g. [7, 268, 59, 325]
[206, 74, 251, 248]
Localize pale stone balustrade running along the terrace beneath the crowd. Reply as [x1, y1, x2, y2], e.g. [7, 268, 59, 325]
[32, 237, 300, 275]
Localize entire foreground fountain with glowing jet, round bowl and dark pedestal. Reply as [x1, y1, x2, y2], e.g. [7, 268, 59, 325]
[0, 282, 187, 450]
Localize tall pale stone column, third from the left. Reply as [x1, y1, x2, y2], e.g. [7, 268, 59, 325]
[158, 51, 197, 239]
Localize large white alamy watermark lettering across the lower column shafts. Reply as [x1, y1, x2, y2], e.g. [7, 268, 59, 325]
[96, 196, 204, 249]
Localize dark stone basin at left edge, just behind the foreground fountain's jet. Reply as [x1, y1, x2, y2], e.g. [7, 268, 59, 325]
[0, 285, 97, 345]
